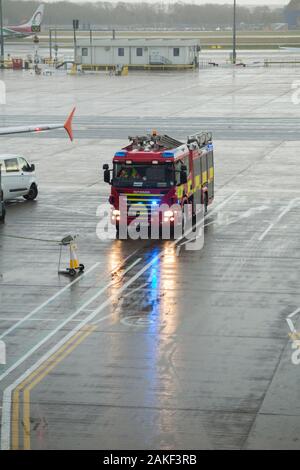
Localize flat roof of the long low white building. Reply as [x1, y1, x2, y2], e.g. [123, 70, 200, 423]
[77, 38, 200, 47]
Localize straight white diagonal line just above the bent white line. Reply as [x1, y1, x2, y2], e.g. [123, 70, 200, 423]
[0, 258, 141, 382]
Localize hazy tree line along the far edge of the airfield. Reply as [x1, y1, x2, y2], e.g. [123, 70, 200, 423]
[3, 0, 284, 28]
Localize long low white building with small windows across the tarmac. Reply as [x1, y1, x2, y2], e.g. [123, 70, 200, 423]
[76, 38, 200, 70]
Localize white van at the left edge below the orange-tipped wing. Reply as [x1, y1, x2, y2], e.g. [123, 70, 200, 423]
[0, 154, 38, 201]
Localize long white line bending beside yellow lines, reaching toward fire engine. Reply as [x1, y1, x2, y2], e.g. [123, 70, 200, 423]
[1, 252, 158, 450]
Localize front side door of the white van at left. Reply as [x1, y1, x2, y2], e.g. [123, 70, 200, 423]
[2, 157, 26, 200]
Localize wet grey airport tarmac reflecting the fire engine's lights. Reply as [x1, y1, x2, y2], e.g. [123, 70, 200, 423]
[0, 62, 300, 449]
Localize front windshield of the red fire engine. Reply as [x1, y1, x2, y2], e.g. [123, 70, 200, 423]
[113, 163, 175, 188]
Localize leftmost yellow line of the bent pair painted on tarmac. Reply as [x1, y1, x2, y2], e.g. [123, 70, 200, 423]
[12, 326, 96, 450]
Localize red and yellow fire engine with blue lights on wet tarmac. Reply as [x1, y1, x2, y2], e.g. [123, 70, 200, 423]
[103, 131, 214, 232]
